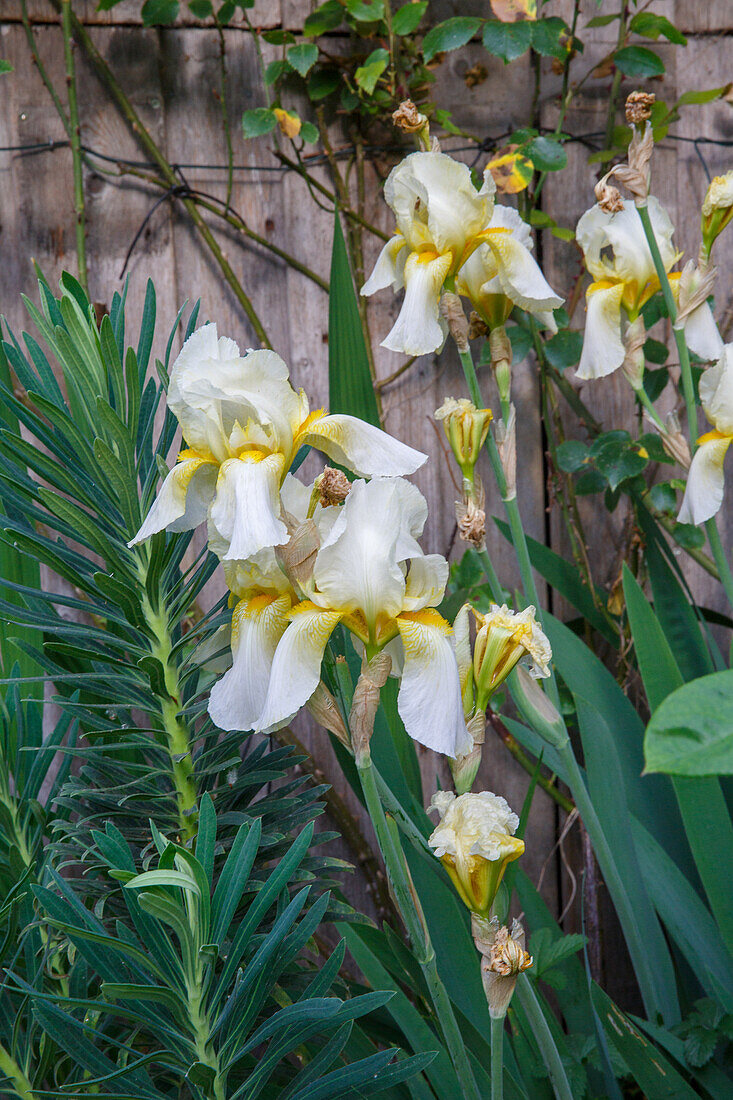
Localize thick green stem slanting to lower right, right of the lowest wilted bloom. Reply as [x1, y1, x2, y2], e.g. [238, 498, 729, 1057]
[558, 739, 665, 1020]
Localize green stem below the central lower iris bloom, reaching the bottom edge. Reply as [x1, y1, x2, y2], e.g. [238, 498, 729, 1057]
[357, 756, 481, 1100]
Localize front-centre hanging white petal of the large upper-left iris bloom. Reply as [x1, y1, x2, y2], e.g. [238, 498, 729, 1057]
[209, 454, 287, 561]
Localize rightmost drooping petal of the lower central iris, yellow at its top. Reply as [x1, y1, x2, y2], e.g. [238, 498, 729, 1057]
[397, 612, 473, 758]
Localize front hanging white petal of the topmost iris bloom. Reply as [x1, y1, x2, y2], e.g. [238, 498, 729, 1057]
[382, 252, 451, 355]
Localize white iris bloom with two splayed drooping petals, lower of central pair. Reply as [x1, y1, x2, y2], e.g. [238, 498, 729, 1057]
[256, 477, 471, 757]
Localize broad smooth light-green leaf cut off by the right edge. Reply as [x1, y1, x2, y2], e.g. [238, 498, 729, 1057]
[644, 669, 733, 776]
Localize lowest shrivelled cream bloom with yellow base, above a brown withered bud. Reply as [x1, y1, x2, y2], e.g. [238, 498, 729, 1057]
[428, 791, 524, 917]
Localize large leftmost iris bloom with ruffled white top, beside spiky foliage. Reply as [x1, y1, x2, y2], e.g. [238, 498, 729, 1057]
[130, 325, 427, 561]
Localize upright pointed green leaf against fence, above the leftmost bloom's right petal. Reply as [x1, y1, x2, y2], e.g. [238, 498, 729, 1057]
[328, 210, 381, 427]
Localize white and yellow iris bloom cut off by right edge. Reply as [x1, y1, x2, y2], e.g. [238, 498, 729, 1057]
[677, 343, 733, 524]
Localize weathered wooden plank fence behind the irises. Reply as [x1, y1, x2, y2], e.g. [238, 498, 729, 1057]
[0, 0, 733, 998]
